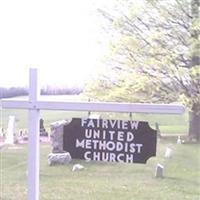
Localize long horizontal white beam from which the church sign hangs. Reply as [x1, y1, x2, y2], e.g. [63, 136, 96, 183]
[1, 100, 185, 114]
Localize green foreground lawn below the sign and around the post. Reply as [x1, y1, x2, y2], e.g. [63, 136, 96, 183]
[0, 139, 200, 200]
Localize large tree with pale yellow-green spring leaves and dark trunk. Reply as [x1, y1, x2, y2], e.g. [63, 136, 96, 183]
[86, 0, 200, 140]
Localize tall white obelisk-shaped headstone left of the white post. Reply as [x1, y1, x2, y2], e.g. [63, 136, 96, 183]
[5, 116, 16, 144]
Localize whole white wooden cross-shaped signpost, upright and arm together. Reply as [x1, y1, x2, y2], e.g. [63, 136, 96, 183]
[0, 69, 184, 200]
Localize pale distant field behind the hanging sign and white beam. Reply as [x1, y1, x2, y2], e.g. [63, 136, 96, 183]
[0, 95, 188, 135]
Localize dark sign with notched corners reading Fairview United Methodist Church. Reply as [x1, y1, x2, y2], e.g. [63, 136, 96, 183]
[63, 118, 157, 163]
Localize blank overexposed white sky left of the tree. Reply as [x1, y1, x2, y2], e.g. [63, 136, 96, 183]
[0, 0, 106, 87]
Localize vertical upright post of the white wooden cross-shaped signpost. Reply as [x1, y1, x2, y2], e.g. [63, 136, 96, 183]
[28, 69, 40, 200]
